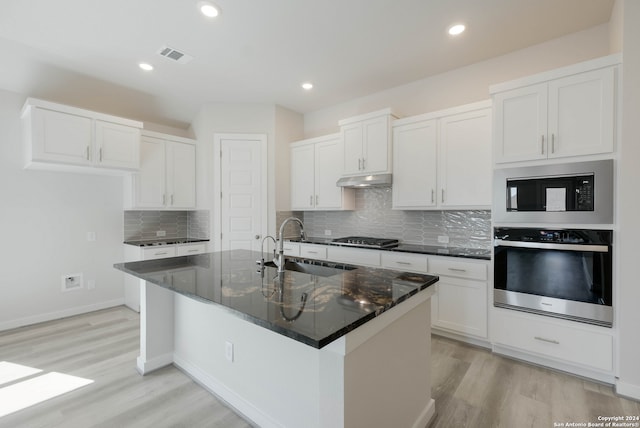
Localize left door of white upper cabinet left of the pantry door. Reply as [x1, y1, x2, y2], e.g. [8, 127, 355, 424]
[134, 137, 166, 208]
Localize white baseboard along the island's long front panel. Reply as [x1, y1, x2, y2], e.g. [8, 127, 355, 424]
[173, 355, 283, 428]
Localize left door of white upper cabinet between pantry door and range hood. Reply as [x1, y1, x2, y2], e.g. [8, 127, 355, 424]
[291, 144, 316, 210]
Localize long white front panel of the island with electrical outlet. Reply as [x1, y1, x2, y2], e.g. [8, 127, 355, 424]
[174, 295, 320, 428]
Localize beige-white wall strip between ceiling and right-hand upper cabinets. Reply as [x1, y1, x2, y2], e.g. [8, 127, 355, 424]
[304, 24, 610, 138]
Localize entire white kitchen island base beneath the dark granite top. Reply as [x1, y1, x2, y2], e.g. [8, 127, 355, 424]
[138, 282, 435, 428]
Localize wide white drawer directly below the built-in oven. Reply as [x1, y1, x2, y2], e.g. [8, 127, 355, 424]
[491, 308, 613, 383]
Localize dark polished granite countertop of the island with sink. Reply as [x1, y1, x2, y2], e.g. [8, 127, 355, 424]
[114, 250, 438, 348]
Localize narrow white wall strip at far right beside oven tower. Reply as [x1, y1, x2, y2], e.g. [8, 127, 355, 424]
[616, 0, 640, 400]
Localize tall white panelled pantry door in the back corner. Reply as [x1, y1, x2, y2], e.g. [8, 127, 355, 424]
[219, 135, 266, 251]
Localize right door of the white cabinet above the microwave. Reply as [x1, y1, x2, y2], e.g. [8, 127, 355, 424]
[549, 68, 615, 157]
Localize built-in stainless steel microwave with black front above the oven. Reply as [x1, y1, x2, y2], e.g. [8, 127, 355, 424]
[492, 159, 613, 224]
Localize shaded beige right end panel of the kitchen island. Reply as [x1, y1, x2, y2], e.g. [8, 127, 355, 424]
[344, 300, 435, 427]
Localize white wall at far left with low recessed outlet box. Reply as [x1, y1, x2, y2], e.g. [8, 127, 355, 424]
[0, 91, 124, 330]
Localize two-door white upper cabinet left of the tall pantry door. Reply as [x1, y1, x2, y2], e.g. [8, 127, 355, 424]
[132, 131, 196, 209]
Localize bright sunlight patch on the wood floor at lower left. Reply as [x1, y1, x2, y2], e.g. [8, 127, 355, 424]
[0, 361, 93, 417]
